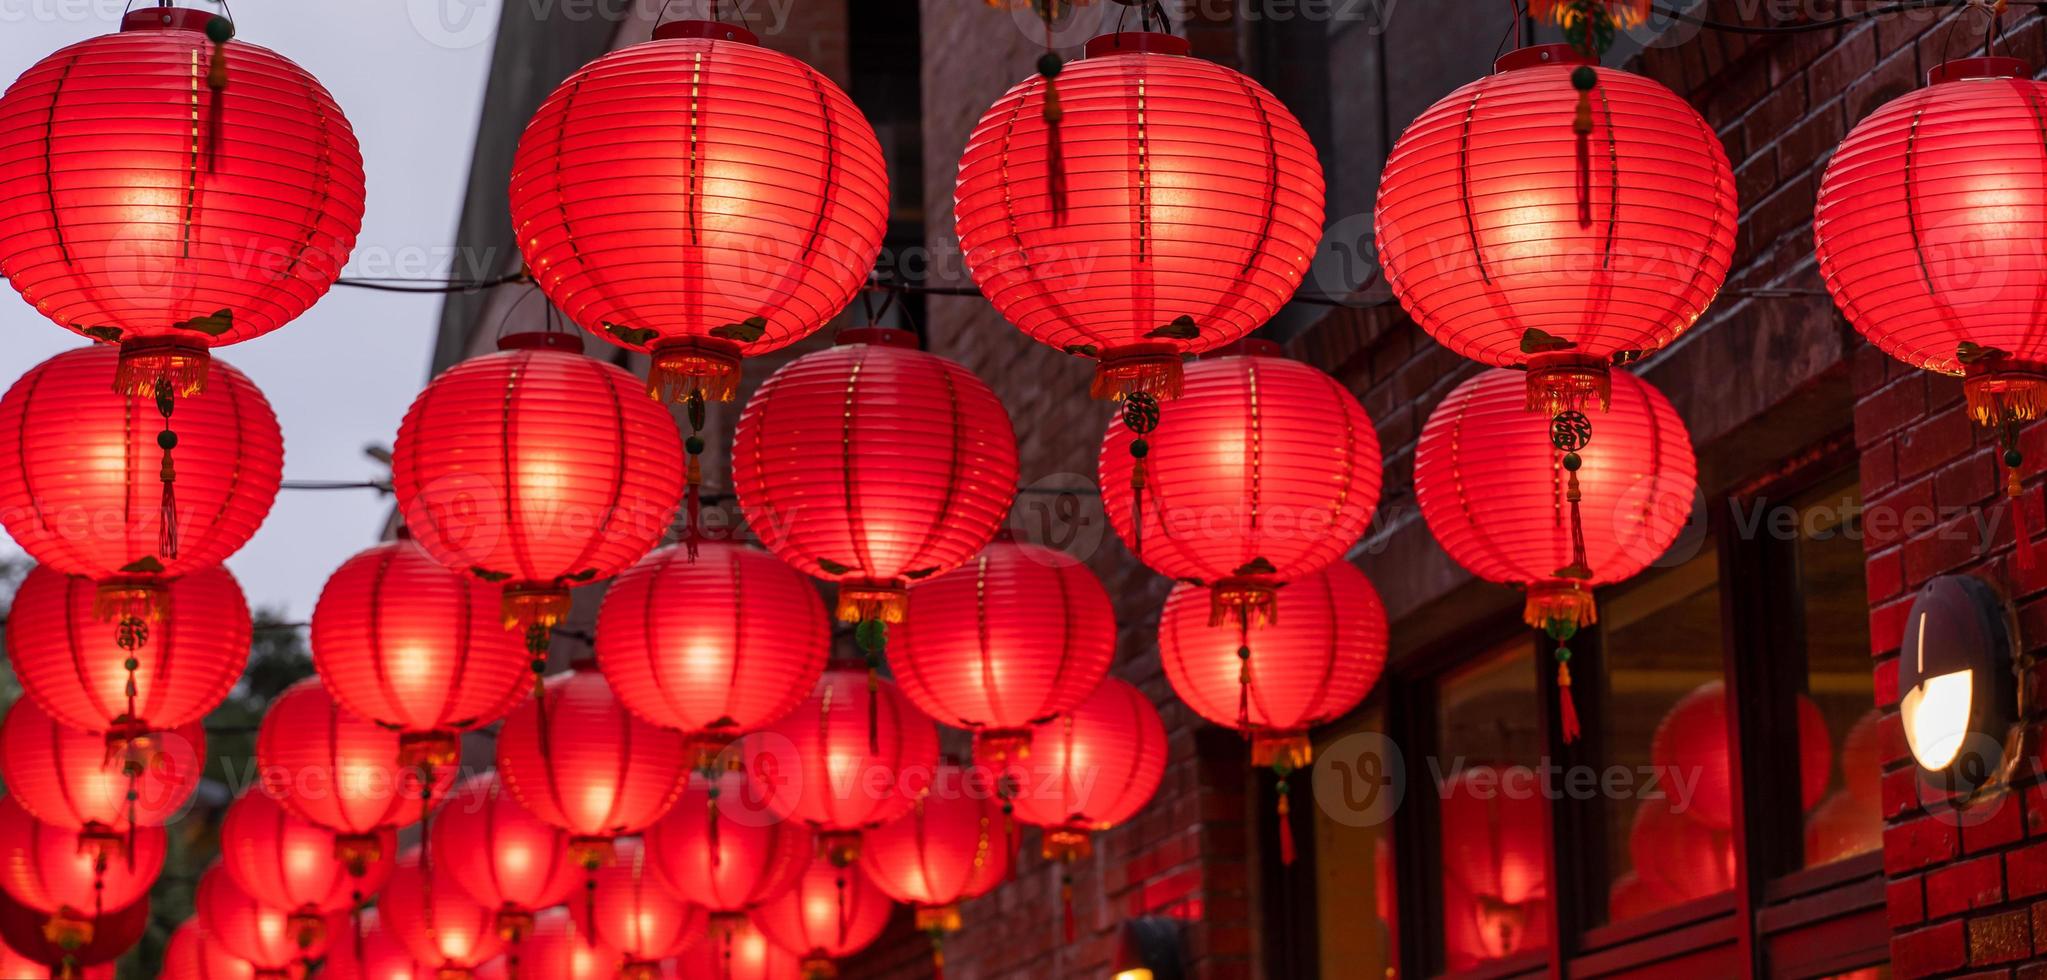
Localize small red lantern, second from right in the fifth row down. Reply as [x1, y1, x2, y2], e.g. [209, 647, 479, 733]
[645, 771, 817, 915]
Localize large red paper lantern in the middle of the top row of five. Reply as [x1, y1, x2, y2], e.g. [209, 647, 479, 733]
[954, 33, 1322, 399]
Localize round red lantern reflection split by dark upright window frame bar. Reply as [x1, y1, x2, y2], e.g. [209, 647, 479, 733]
[1650, 681, 1834, 829]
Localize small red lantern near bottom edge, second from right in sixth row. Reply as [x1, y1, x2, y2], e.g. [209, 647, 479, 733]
[569, 837, 706, 980]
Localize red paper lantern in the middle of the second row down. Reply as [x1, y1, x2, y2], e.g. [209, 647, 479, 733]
[733, 329, 1017, 622]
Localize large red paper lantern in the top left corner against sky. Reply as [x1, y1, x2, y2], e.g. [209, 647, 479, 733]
[0, 8, 362, 396]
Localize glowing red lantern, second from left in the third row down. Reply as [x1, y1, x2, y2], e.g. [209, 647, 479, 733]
[311, 538, 532, 765]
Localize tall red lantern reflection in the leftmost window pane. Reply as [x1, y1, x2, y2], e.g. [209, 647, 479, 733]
[1441, 765, 1550, 968]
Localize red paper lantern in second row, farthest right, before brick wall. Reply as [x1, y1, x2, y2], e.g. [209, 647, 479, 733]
[1414, 370, 1699, 626]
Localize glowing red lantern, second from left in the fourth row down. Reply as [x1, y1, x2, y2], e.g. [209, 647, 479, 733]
[256, 677, 454, 863]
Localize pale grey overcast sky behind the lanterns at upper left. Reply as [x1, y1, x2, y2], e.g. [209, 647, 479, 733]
[0, 0, 497, 618]
